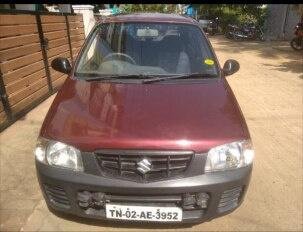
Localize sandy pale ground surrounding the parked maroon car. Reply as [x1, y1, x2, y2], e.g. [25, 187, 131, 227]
[0, 37, 303, 231]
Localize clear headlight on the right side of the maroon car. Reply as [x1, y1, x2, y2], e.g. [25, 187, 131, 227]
[205, 140, 254, 172]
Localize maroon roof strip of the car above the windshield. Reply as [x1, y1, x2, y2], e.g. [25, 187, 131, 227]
[99, 13, 198, 24]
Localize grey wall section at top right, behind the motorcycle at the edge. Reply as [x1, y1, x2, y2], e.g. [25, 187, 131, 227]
[265, 4, 300, 40]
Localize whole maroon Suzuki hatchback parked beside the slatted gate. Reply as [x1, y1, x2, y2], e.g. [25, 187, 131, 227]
[35, 14, 254, 223]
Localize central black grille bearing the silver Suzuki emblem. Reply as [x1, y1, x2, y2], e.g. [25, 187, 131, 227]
[96, 152, 193, 182]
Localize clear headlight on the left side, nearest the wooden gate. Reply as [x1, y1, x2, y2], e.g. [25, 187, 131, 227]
[35, 138, 83, 171]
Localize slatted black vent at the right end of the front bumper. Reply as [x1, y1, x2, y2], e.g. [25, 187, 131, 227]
[218, 187, 243, 213]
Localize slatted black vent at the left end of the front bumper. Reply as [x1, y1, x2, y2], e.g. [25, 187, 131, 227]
[44, 185, 70, 208]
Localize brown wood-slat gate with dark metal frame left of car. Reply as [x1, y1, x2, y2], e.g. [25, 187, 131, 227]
[0, 10, 85, 131]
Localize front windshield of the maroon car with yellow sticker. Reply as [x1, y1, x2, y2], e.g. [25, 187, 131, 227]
[75, 23, 218, 79]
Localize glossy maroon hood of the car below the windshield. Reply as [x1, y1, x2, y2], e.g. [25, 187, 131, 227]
[41, 78, 249, 152]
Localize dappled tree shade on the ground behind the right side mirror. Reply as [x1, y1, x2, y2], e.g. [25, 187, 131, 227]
[212, 35, 303, 79]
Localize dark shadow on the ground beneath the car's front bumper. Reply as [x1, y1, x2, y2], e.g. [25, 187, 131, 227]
[48, 208, 195, 229]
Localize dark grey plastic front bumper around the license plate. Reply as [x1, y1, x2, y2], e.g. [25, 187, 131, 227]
[36, 161, 252, 223]
